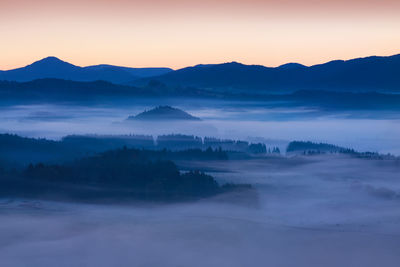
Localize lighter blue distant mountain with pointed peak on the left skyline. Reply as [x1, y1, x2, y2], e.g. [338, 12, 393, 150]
[0, 57, 172, 84]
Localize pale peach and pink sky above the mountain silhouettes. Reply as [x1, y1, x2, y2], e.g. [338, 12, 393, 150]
[0, 0, 400, 70]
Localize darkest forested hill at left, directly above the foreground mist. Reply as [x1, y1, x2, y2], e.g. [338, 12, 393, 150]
[0, 148, 250, 202]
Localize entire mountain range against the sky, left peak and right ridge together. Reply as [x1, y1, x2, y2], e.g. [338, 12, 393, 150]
[0, 54, 400, 94]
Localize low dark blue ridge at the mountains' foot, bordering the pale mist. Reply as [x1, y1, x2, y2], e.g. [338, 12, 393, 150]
[0, 79, 400, 110]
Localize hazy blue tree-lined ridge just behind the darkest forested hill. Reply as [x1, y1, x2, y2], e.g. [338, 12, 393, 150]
[0, 134, 280, 166]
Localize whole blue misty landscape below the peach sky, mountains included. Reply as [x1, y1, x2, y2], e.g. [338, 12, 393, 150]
[0, 55, 400, 267]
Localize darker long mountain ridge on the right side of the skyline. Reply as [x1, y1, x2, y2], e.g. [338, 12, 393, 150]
[134, 54, 400, 93]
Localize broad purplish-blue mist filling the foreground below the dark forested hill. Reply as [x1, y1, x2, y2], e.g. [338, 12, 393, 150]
[0, 155, 400, 267]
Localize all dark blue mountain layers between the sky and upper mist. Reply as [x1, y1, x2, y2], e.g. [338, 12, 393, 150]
[0, 55, 400, 109]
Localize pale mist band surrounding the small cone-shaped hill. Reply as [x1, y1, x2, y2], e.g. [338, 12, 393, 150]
[0, 99, 400, 155]
